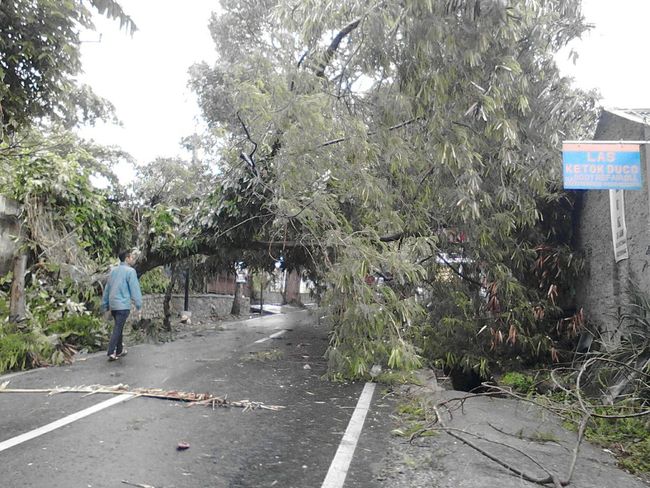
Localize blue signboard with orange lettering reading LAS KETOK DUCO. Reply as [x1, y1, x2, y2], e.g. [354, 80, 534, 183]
[562, 142, 643, 190]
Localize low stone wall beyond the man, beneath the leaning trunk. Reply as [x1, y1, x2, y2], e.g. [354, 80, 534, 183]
[131, 294, 250, 322]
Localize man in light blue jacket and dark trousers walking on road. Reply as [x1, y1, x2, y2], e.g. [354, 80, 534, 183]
[102, 250, 142, 361]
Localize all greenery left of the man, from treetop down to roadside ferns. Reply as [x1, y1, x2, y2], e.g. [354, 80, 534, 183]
[0, 0, 135, 372]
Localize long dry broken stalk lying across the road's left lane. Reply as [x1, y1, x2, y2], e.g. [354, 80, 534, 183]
[0, 381, 284, 412]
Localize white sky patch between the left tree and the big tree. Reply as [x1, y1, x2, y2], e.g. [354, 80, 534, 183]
[80, 0, 219, 180]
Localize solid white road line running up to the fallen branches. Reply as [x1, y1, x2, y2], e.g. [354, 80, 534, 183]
[321, 383, 375, 488]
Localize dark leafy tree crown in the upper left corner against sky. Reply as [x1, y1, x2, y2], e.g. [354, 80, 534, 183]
[0, 0, 136, 132]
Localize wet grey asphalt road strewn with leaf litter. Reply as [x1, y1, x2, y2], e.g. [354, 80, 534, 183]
[0, 312, 393, 488]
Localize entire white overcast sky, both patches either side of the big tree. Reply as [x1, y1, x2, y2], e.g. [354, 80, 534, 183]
[82, 0, 650, 180]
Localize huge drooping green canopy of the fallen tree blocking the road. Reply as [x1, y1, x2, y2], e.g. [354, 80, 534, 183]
[187, 0, 596, 375]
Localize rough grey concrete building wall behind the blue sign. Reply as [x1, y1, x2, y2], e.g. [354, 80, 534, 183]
[575, 111, 650, 346]
